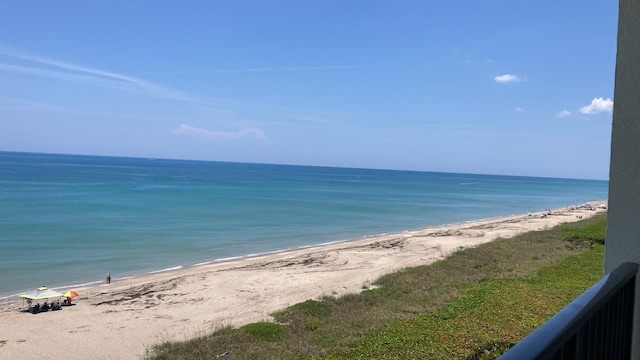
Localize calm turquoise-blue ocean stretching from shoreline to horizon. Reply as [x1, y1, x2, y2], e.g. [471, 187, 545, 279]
[0, 152, 608, 300]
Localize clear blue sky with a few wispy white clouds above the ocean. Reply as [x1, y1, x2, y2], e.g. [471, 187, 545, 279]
[0, 0, 617, 179]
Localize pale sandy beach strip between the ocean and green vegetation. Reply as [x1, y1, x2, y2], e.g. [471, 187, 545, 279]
[0, 202, 605, 359]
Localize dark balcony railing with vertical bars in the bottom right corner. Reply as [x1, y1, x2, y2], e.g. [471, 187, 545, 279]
[500, 263, 638, 360]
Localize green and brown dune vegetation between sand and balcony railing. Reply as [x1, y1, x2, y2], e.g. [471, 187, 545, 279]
[148, 214, 605, 360]
